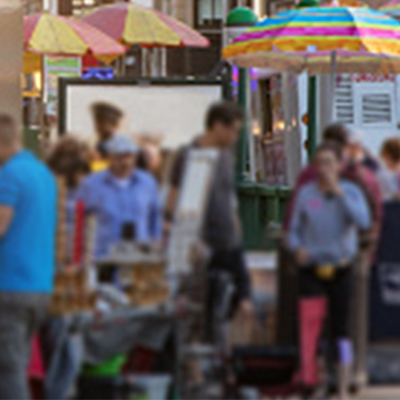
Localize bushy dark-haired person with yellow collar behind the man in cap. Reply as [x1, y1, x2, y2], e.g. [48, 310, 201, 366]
[91, 102, 124, 170]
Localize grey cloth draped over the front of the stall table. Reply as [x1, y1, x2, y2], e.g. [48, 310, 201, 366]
[44, 306, 175, 399]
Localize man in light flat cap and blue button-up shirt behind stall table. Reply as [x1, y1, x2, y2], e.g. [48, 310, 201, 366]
[79, 136, 162, 259]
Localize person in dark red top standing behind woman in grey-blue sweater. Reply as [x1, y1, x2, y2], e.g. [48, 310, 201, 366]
[284, 123, 382, 388]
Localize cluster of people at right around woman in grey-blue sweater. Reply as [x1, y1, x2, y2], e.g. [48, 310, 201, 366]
[284, 124, 400, 399]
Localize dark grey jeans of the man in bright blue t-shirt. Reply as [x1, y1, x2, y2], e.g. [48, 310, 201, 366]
[0, 293, 48, 400]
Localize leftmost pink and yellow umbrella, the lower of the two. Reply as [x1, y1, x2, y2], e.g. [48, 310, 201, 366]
[24, 13, 126, 72]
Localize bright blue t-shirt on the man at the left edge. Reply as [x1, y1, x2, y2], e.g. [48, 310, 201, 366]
[0, 151, 57, 293]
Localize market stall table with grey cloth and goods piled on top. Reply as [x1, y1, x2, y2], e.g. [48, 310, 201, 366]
[45, 247, 177, 398]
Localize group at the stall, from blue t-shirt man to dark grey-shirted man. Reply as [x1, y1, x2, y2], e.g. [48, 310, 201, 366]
[0, 103, 250, 399]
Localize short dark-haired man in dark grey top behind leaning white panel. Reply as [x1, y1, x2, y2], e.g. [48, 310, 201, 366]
[167, 102, 251, 338]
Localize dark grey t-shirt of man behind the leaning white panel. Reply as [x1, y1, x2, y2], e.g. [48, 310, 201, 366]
[171, 143, 241, 250]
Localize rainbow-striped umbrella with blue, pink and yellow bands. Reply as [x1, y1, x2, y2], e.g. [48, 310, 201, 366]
[223, 7, 400, 75]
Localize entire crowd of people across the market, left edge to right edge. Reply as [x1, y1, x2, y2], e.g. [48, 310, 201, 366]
[0, 98, 400, 399]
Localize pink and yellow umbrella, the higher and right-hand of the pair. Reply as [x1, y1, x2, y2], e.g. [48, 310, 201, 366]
[84, 2, 209, 47]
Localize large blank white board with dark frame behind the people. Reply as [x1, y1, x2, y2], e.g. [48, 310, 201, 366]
[64, 82, 222, 149]
